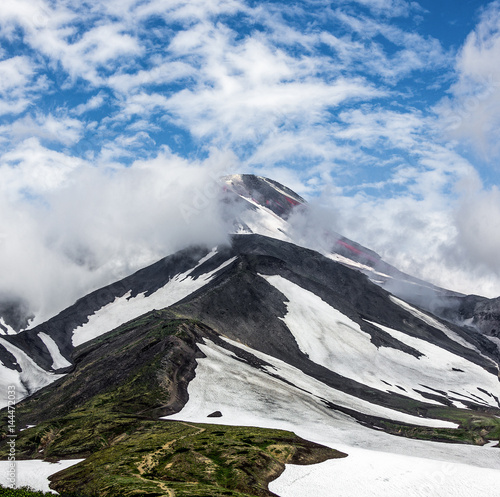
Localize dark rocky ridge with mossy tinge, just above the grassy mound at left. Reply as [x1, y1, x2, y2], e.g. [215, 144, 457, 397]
[7, 311, 216, 424]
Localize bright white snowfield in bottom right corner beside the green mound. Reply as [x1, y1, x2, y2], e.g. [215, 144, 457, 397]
[269, 447, 500, 497]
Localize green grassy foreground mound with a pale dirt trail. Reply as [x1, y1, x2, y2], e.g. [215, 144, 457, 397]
[47, 421, 345, 496]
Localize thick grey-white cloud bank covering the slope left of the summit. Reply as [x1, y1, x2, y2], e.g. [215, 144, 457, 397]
[0, 143, 235, 322]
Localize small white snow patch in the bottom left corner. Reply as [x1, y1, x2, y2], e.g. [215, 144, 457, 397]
[0, 459, 84, 494]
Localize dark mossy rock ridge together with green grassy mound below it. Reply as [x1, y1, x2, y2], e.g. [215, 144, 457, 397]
[0, 311, 345, 497]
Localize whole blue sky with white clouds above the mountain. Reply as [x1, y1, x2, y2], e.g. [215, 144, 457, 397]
[0, 0, 500, 318]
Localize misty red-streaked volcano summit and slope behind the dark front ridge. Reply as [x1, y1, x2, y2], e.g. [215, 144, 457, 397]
[224, 174, 500, 345]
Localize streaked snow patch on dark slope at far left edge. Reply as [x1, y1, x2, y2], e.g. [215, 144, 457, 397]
[0, 337, 64, 408]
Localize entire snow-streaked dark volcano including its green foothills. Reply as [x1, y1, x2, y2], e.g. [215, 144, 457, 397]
[0, 175, 500, 497]
